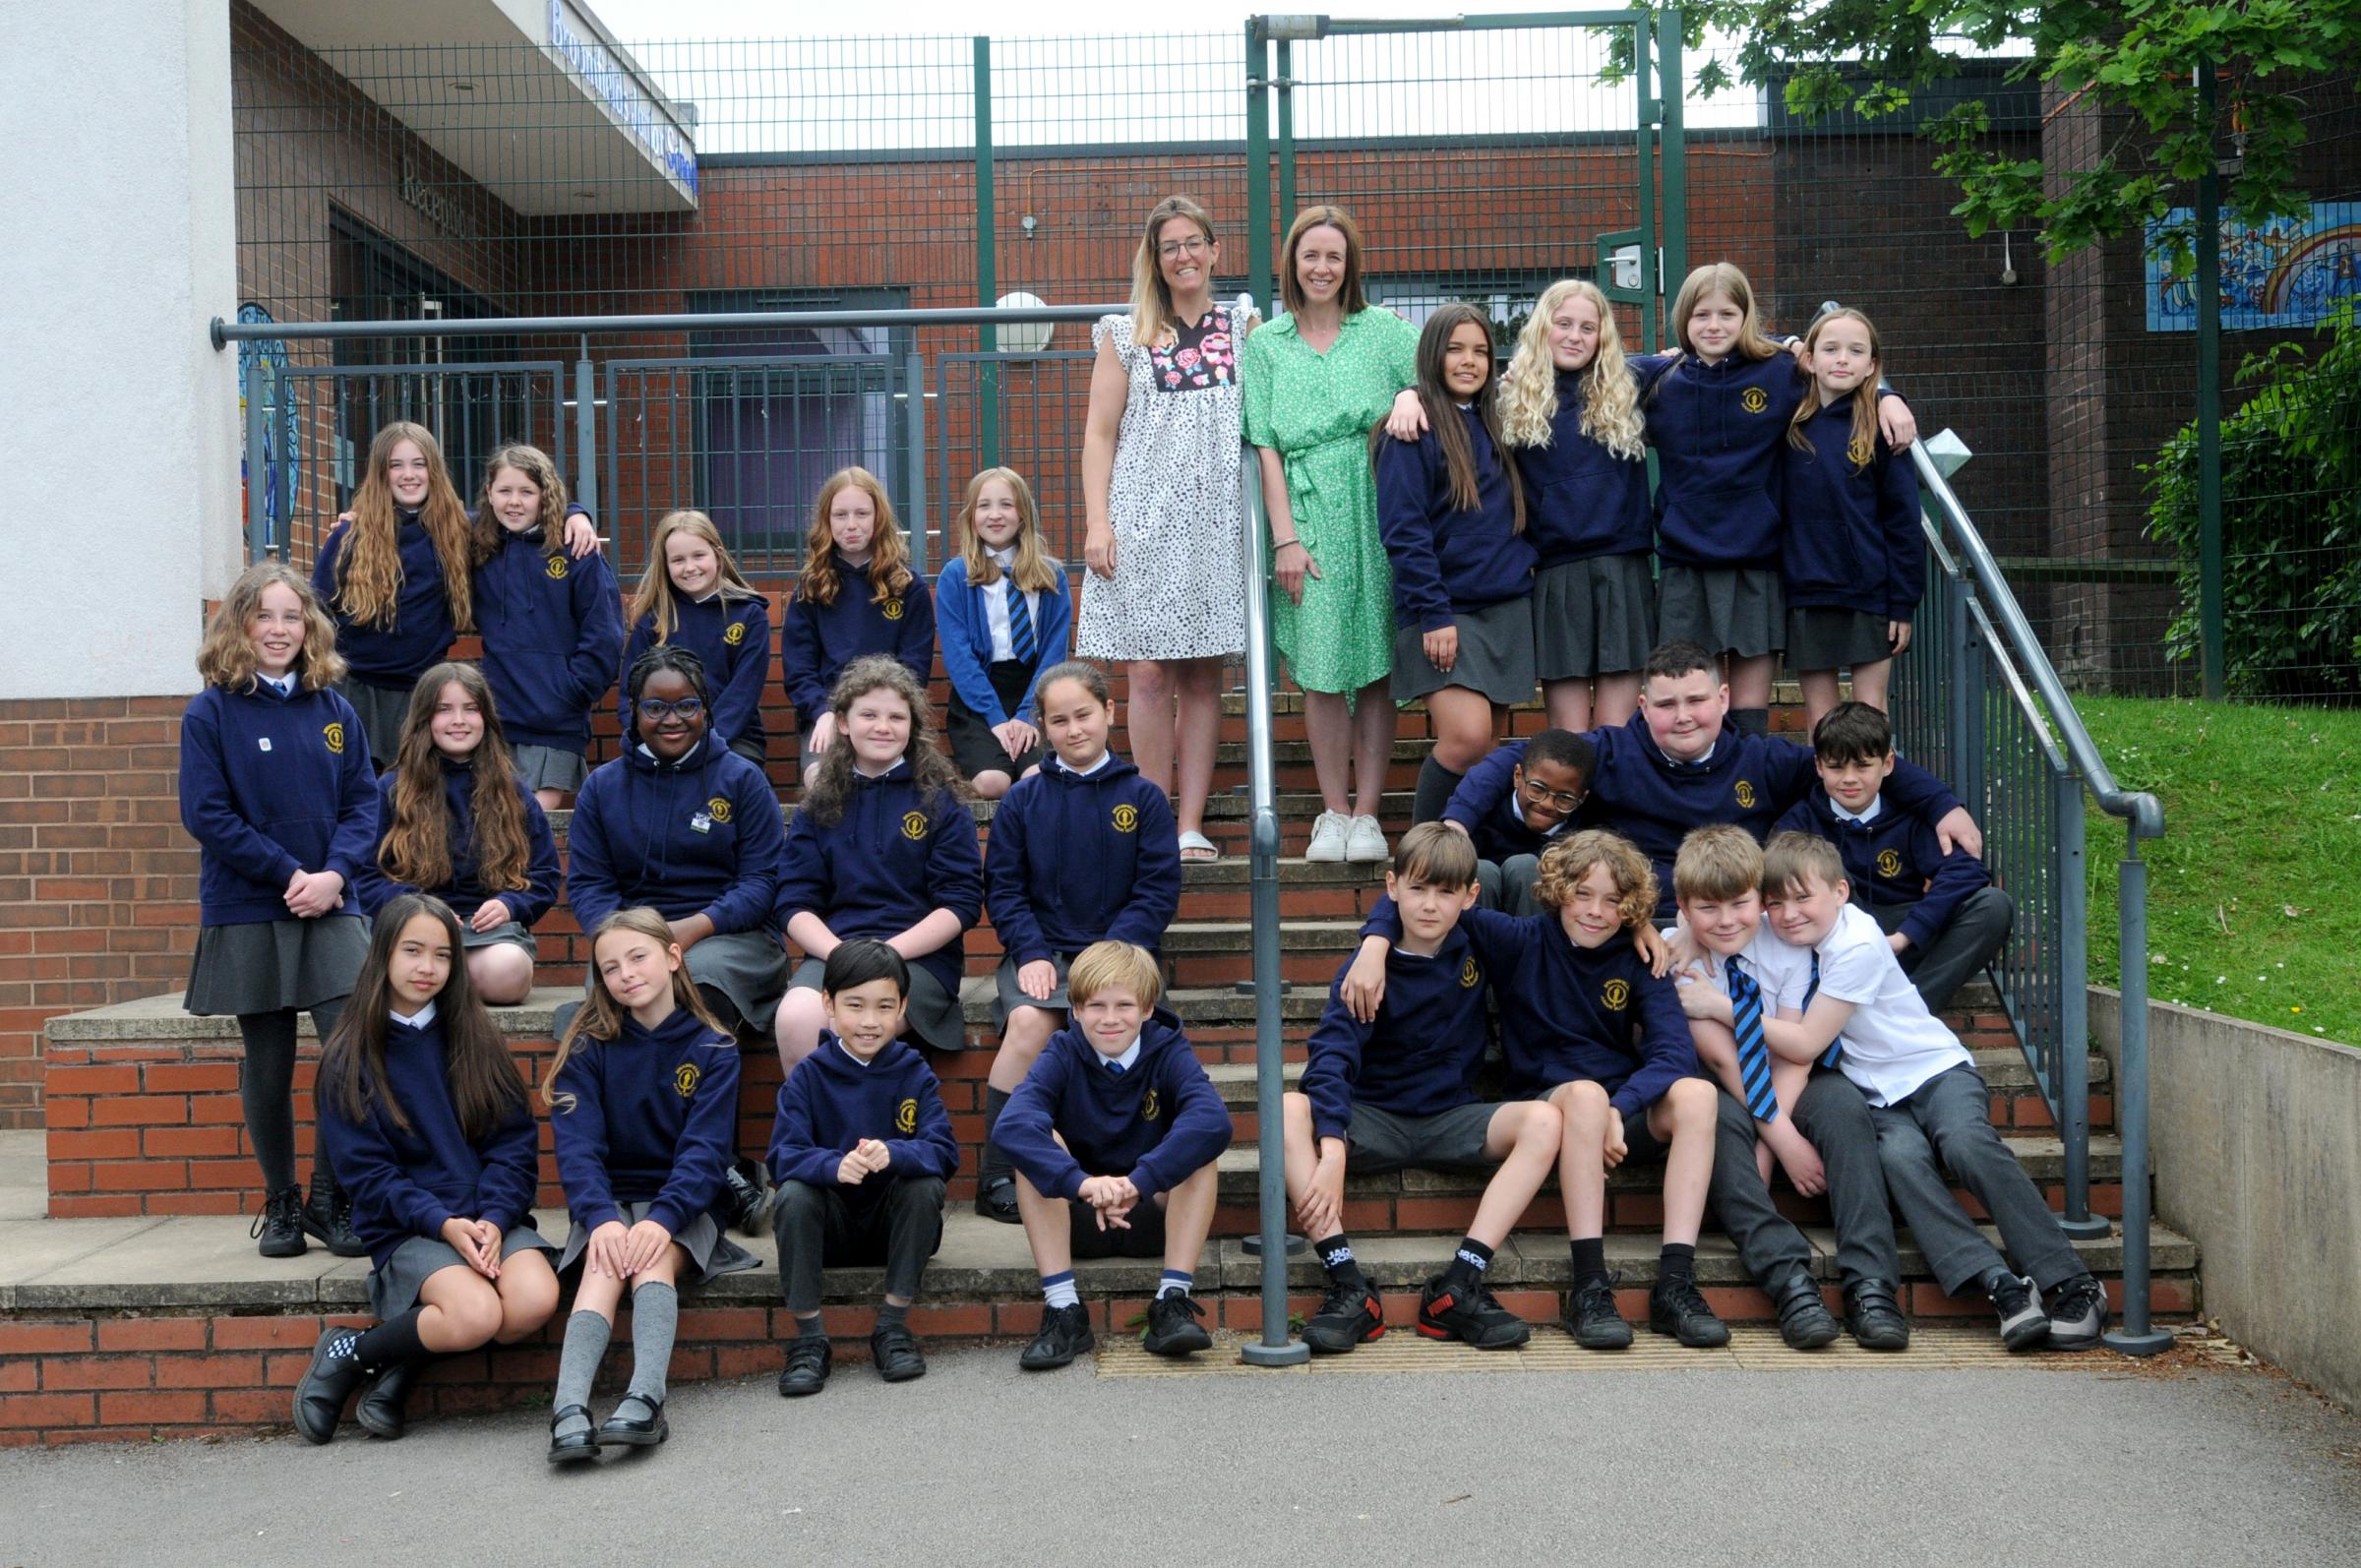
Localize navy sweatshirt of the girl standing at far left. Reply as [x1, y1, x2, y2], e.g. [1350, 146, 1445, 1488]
[179, 680, 378, 926]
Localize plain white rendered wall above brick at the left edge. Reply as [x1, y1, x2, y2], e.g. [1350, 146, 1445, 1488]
[0, 0, 243, 699]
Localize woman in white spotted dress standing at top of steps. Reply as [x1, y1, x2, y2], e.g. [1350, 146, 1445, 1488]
[1074, 196, 1256, 860]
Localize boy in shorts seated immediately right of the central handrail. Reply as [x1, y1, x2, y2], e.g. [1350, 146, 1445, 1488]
[1285, 821, 1565, 1356]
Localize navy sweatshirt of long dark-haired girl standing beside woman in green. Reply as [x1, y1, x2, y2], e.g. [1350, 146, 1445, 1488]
[1376, 408, 1533, 631]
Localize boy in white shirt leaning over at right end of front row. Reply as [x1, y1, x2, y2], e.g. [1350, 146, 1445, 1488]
[1764, 833, 2106, 1351]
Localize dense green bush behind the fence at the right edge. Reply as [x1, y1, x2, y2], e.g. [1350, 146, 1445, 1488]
[2147, 302, 2361, 703]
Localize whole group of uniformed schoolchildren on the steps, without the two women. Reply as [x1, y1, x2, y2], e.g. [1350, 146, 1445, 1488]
[182, 267, 2106, 1462]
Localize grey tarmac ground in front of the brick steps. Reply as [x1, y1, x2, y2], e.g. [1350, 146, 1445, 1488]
[0, 1337, 2361, 1568]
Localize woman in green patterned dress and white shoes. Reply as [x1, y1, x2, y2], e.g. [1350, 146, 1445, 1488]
[1241, 206, 1419, 862]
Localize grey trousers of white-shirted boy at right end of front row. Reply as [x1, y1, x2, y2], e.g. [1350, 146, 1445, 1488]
[1870, 1062, 2085, 1297]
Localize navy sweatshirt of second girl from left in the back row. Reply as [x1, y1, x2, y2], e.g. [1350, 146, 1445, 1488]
[474, 529, 623, 751]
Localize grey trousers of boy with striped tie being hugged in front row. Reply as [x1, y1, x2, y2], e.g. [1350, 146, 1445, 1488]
[1707, 1069, 1903, 1290]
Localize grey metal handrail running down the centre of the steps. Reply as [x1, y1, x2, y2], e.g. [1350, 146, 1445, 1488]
[1238, 447, 1310, 1367]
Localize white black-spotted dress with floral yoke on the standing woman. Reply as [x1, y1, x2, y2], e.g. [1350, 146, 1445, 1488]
[1074, 295, 1251, 659]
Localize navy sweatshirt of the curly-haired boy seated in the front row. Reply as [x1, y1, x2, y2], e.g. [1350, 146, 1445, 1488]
[1360, 897, 1698, 1116]
